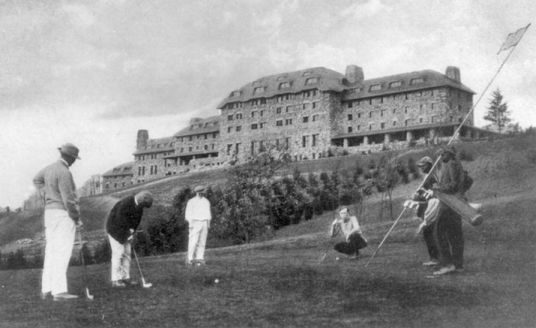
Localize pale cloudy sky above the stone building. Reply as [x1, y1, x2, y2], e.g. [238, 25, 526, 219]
[0, 0, 536, 208]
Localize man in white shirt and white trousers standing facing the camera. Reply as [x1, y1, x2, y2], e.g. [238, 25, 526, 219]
[184, 186, 212, 266]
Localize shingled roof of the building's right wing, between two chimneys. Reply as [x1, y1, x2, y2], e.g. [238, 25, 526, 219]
[343, 70, 475, 100]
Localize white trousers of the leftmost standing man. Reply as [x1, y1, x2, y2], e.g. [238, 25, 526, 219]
[41, 209, 76, 295]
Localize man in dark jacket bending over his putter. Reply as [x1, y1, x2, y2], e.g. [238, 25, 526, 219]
[106, 191, 153, 288]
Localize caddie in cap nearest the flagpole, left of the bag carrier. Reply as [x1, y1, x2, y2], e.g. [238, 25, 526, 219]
[406, 156, 440, 266]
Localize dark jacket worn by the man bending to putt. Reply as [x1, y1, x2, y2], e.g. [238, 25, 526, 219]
[106, 195, 143, 244]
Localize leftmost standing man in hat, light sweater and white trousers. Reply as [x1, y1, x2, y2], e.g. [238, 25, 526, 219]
[33, 143, 83, 301]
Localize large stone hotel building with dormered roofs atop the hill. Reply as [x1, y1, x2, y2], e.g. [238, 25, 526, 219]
[103, 65, 490, 190]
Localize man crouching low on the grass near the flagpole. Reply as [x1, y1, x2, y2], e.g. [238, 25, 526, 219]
[330, 207, 367, 259]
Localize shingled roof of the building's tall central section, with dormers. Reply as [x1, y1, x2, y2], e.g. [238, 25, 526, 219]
[217, 67, 346, 109]
